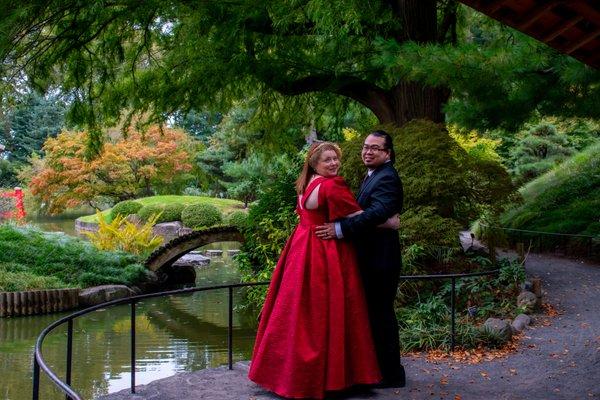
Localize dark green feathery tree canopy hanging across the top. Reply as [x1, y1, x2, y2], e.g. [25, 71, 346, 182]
[0, 0, 600, 138]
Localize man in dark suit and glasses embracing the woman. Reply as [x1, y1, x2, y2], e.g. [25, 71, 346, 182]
[317, 131, 406, 387]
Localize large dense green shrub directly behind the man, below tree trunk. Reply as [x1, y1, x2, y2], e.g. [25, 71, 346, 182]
[340, 120, 515, 272]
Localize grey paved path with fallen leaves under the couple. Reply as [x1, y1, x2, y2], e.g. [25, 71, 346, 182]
[102, 255, 600, 400]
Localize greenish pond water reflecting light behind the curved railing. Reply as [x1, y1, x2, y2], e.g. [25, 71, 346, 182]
[0, 216, 256, 400]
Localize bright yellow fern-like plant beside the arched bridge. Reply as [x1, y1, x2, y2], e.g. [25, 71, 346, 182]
[85, 211, 163, 255]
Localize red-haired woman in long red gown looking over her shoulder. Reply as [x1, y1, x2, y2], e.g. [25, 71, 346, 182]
[248, 142, 392, 399]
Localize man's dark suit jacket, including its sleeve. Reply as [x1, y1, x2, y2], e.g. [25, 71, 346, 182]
[340, 162, 403, 280]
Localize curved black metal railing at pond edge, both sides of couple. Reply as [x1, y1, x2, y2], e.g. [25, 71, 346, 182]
[33, 270, 498, 400]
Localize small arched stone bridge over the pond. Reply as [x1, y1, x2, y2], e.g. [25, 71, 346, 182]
[145, 226, 244, 284]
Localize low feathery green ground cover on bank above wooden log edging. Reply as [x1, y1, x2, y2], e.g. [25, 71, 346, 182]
[0, 224, 146, 291]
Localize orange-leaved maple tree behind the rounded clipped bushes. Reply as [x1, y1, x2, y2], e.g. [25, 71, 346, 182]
[29, 126, 194, 214]
